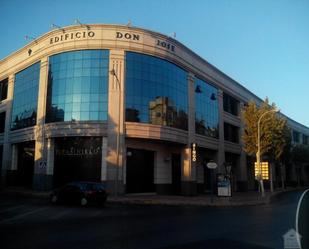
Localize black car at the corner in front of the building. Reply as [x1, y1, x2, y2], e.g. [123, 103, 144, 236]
[50, 182, 107, 206]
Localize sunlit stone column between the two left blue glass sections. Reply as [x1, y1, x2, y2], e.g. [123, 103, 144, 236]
[33, 57, 53, 190]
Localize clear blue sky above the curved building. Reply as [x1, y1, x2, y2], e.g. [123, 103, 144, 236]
[0, 0, 309, 127]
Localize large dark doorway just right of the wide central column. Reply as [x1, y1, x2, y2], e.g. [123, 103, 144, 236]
[126, 148, 155, 193]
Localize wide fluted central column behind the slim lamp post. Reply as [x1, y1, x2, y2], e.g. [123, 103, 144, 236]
[106, 50, 125, 195]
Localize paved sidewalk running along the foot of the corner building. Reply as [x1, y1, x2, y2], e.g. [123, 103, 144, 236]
[0, 187, 300, 207]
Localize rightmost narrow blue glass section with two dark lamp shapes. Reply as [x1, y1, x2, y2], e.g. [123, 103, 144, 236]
[195, 78, 219, 138]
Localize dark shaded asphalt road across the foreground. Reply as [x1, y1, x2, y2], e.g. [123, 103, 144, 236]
[0, 191, 309, 249]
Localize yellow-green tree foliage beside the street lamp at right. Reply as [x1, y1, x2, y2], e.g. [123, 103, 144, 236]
[242, 99, 289, 159]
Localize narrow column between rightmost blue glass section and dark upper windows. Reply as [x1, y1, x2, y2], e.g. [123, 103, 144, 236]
[217, 89, 225, 173]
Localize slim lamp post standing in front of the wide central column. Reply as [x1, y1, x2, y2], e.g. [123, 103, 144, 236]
[109, 68, 121, 196]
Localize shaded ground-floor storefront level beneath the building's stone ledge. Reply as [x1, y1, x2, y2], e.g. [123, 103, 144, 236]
[1, 136, 305, 195]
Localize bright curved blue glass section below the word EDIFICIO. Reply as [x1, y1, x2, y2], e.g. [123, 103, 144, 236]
[46, 50, 109, 123]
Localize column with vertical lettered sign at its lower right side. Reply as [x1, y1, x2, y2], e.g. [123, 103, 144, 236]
[181, 73, 198, 195]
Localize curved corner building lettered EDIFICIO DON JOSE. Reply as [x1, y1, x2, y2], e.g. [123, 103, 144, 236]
[0, 25, 309, 195]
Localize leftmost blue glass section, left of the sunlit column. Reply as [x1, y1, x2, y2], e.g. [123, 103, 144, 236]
[11, 62, 40, 130]
